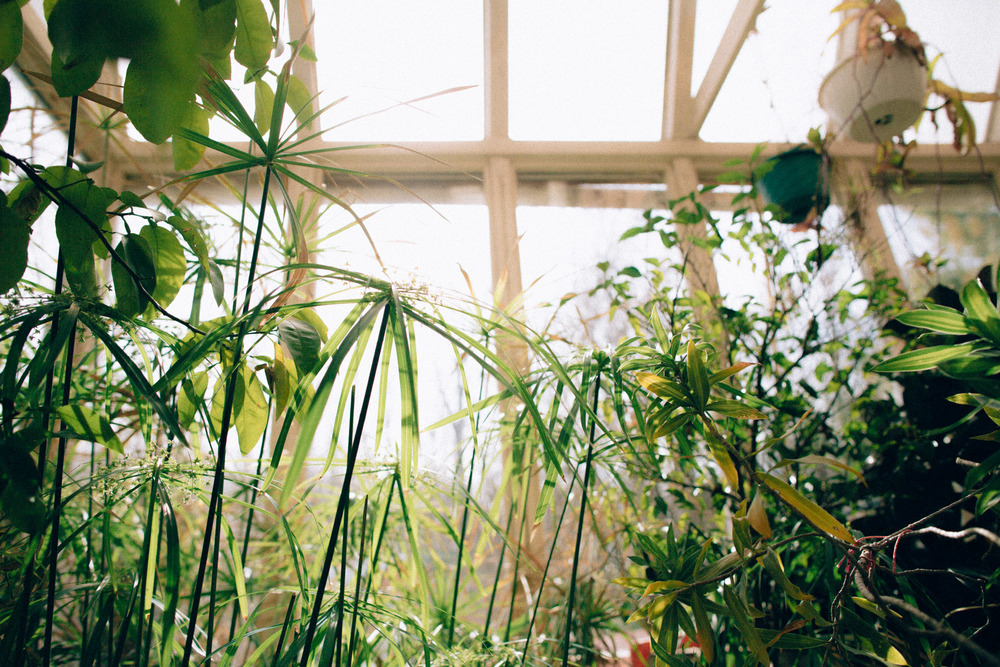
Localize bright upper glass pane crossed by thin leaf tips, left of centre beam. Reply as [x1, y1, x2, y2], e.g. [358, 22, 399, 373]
[314, 0, 485, 141]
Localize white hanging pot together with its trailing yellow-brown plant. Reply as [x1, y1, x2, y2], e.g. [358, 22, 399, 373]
[819, 0, 997, 150]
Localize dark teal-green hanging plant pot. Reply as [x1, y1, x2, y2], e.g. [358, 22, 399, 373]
[757, 147, 830, 225]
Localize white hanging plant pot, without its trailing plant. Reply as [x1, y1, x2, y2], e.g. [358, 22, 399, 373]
[819, 44, 927, 143]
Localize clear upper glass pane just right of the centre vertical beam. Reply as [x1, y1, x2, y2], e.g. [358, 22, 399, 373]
[508, 0, 667, 141]
